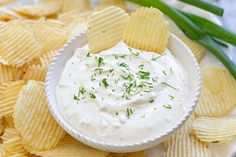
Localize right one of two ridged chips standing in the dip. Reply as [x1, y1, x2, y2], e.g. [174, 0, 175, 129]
[124, 7, 170, 54]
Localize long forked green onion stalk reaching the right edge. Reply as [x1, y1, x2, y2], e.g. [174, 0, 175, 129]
[127, 0, 236, 79]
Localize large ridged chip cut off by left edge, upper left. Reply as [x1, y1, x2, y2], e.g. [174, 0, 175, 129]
[0, 24, 41, 67]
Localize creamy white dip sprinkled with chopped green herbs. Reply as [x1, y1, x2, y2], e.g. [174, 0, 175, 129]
[57, 42, 191, 144]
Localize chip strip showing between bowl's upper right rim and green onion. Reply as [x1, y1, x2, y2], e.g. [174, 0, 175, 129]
[169, 21, 206, 62]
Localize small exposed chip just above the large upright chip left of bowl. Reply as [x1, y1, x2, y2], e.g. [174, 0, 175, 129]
[23, 64, 48, 82]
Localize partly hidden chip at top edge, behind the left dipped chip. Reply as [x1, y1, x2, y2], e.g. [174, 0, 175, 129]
[98, 0, 126, 9]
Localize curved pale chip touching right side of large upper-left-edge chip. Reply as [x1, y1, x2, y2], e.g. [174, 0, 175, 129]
[33, 20, 67, 53]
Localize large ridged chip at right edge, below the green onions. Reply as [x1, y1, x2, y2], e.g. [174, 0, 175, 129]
[196, 65, 236, 117]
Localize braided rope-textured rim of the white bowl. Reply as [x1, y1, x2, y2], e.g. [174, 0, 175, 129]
[45, 34, 202, 152]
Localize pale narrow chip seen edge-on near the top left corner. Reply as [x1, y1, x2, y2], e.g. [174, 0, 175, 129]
[12, 2, 62, 16]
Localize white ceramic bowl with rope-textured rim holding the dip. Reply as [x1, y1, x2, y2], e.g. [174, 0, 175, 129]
[45, 35, 201, 153]
